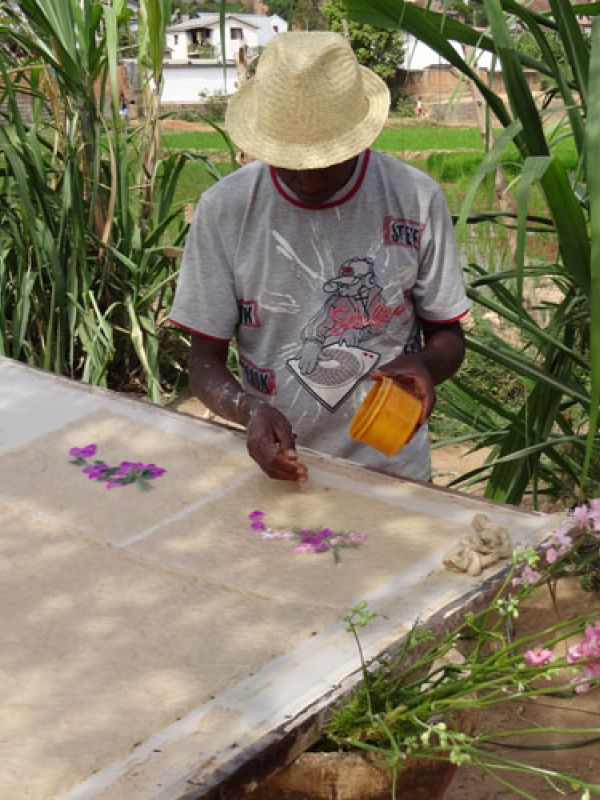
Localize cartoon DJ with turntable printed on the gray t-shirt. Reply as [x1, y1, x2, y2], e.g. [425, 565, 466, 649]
[286, 257, 412, 412]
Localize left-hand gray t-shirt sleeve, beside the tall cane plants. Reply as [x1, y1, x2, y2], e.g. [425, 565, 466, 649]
[169, 191, 239, 341]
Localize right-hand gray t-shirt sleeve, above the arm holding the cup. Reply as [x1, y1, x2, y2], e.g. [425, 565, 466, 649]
[413, 187, 471, 322]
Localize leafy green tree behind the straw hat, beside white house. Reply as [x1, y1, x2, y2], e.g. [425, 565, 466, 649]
[321, 0, 404, 89]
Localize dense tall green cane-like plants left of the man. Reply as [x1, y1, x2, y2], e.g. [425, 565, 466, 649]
[0, 0, 199, 401]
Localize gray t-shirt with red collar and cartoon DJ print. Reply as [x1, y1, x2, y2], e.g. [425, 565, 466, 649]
[170, 151, 469, 480]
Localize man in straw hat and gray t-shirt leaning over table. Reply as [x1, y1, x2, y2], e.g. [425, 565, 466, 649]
[171, 32, 469, 481]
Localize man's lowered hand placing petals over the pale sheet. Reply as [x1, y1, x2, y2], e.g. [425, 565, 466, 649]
[247, 403, 308, 483]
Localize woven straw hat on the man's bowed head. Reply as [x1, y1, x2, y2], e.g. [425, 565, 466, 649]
[225, 31, 390, 170]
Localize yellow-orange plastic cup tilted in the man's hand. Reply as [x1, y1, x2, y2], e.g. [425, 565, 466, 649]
[348, 377, 423, 456]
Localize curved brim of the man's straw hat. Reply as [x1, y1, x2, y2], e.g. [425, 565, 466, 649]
[225, 67, 390, 170]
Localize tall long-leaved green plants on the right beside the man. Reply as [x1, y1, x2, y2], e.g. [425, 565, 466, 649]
[345, 0, 600, 503]
